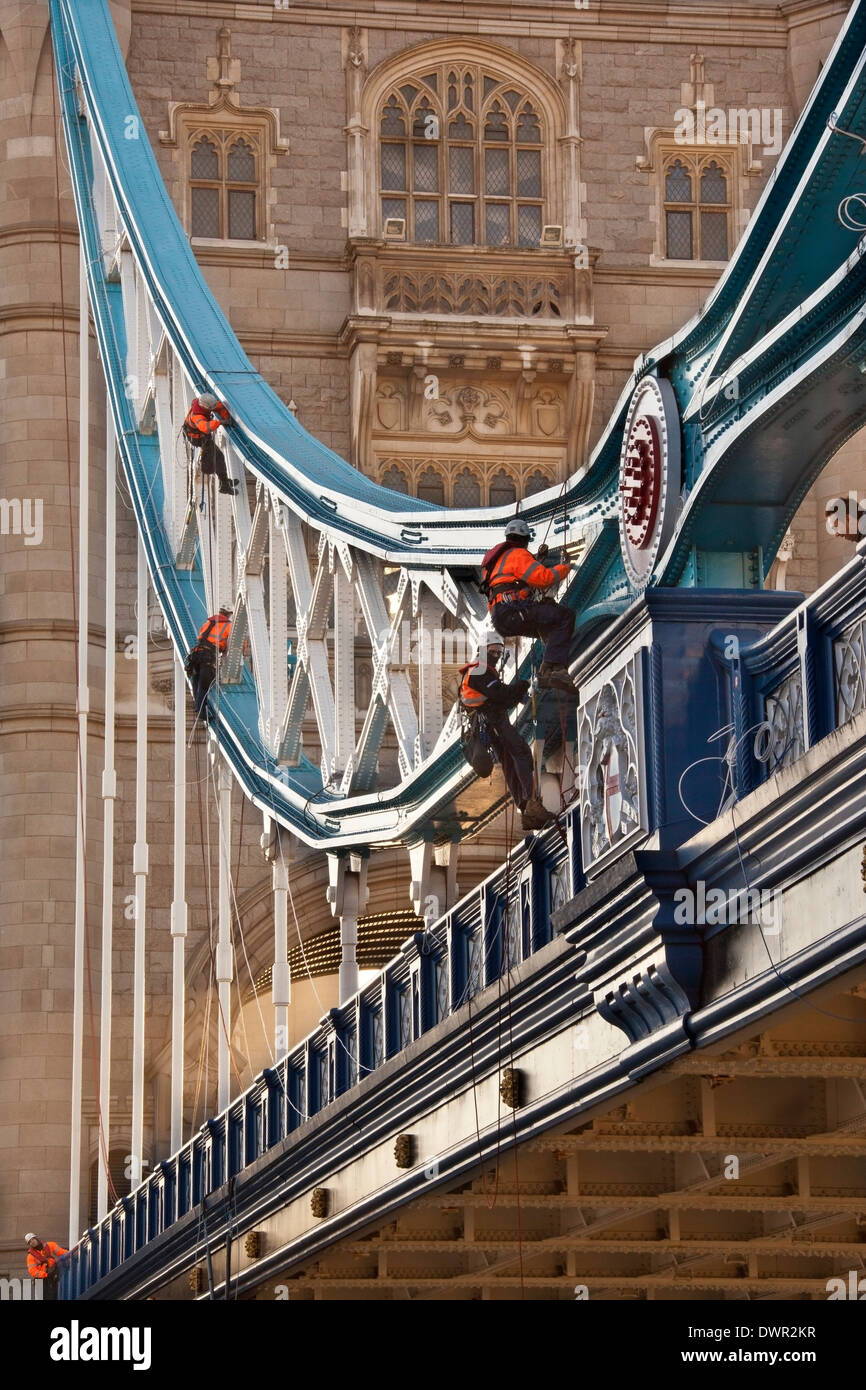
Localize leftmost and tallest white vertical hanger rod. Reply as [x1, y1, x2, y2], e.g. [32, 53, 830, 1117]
[70, 250, 90, 1245]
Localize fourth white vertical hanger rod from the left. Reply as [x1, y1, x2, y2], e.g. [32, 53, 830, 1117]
[171, 653, 186, 1154]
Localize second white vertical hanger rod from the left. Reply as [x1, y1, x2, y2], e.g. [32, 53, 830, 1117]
[96, 406, 117, 1220]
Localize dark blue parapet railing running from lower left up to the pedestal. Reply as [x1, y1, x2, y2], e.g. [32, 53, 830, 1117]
[61, 827, 582, 1298]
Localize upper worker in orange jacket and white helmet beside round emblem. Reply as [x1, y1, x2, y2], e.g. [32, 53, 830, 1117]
[481, 517, 574, 695]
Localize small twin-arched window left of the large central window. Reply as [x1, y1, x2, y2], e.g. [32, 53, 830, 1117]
[189, 126, 263, 242]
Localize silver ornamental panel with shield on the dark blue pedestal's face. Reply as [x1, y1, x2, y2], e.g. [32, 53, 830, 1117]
[577, 656, 646, 872]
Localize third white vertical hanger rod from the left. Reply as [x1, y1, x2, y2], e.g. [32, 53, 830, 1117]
[131, 537, 147, 1184]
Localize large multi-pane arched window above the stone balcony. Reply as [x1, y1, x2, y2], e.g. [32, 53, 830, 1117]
[377, 64, 545, 246]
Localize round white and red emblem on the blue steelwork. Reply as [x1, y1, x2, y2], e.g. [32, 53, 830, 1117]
[620, 377, 680, 589]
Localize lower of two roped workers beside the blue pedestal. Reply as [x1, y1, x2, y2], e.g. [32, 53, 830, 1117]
[460, 631, 550, 833]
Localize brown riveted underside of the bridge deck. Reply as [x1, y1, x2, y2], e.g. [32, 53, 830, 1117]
[145, 983, 866, 1301]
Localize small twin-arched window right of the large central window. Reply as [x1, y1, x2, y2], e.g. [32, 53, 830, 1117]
[663, 154, 733, 261]
